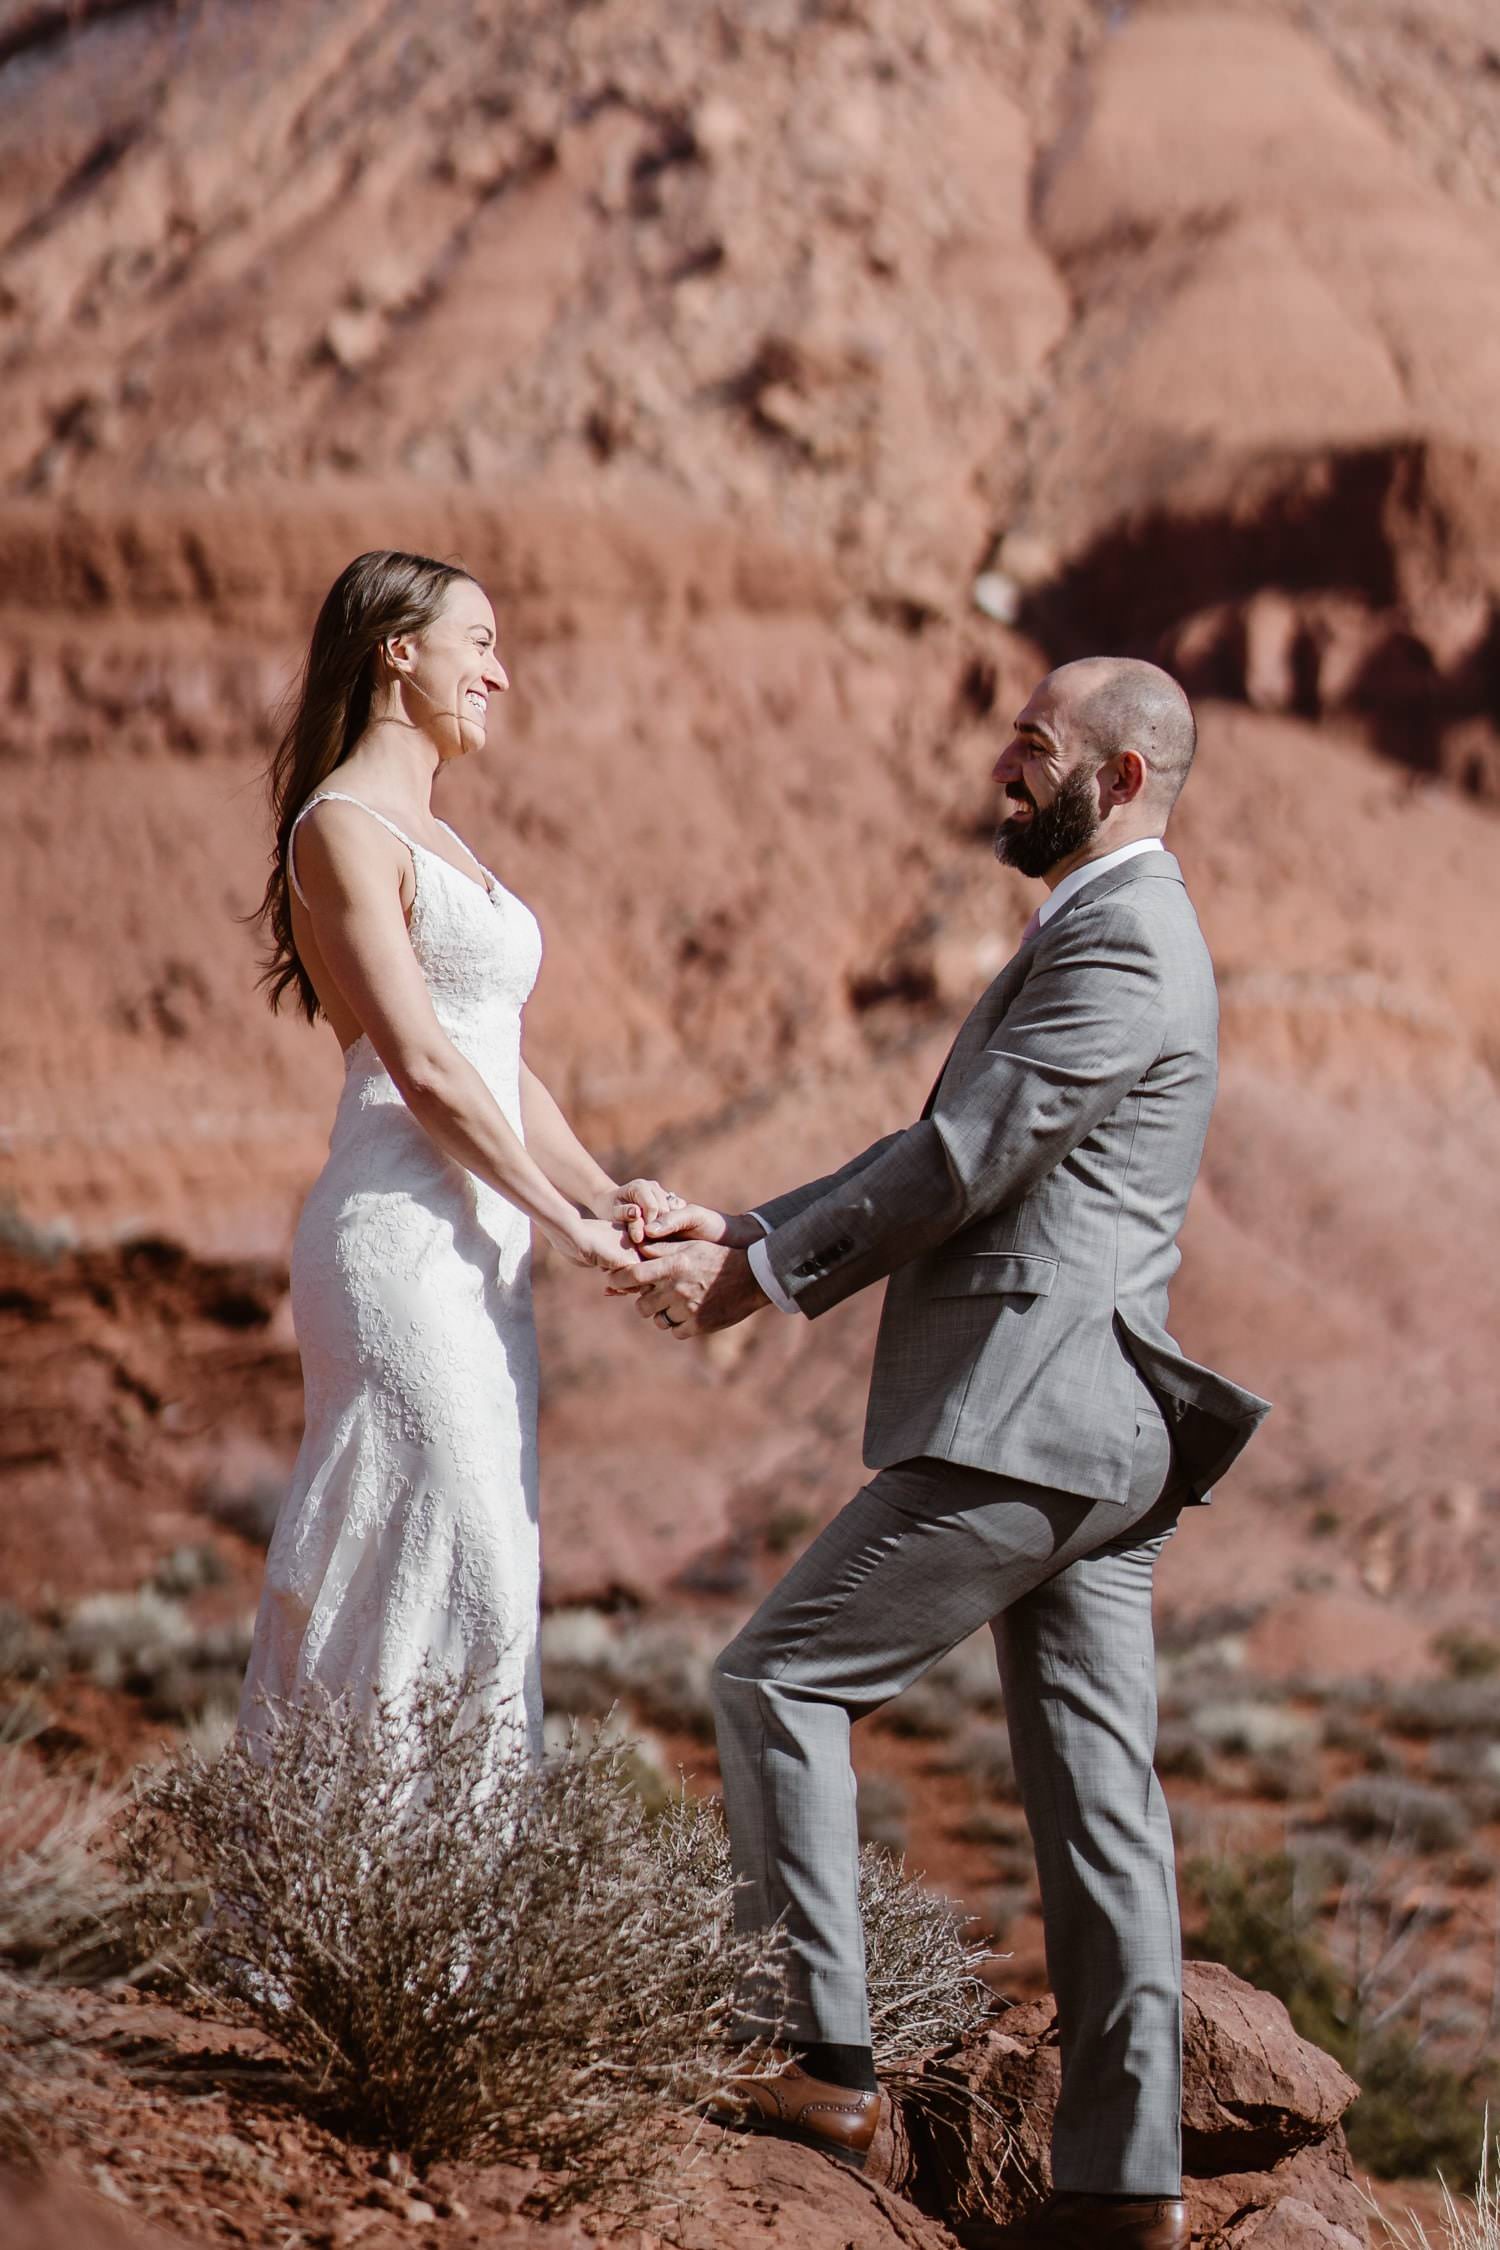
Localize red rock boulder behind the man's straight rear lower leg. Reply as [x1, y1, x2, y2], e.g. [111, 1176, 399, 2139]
[873, 1962, 1367, 2250]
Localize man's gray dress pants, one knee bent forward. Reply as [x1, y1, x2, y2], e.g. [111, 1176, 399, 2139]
[713, 1384, 1185, 2196]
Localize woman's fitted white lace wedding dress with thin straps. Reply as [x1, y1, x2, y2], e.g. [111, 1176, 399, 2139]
[241, 790, 542, 1757]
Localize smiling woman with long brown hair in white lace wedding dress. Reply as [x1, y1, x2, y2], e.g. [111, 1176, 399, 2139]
[241, 551, 677, 1757]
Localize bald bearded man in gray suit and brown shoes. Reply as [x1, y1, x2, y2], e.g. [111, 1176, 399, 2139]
[612, 657, 1268, 2250]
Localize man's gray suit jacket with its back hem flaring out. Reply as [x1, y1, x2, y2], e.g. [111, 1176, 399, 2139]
[758, 853, 1271, 1501]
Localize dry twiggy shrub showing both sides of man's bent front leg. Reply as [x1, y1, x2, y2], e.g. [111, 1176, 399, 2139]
[657, 1798, 992, 2072]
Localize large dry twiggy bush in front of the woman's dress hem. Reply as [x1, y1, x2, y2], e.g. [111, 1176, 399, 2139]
[126, 1681, 776, 2210]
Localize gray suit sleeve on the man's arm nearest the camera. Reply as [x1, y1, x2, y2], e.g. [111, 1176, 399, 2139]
[762, 898, 1165, 1319]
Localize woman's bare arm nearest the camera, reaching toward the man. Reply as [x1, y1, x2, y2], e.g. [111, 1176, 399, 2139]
[297, 803, 636, 1269]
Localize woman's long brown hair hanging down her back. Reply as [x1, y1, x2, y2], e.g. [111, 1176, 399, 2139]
[254, 547, 470, 1024]
